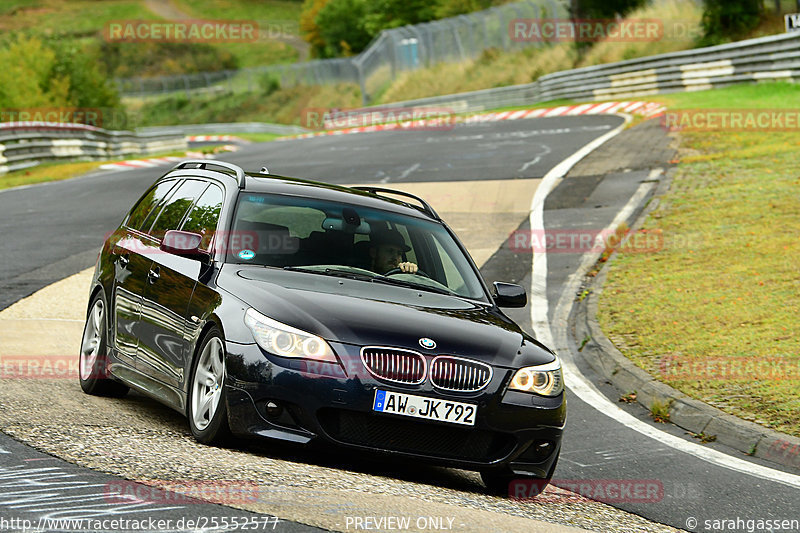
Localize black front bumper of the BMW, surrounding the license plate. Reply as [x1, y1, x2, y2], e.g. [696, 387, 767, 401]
[225, 343, 566, 477]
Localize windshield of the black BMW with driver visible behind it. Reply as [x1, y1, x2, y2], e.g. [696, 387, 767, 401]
[227, 193, 486, 301]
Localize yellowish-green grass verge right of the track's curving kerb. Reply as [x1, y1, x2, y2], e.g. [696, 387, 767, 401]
[599, 83, 800, 436]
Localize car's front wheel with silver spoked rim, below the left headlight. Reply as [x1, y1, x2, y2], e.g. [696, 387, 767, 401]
[187, 328, 230, 445]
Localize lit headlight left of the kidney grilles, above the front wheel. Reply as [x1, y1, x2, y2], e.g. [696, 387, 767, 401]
[244, 307, 336, 363]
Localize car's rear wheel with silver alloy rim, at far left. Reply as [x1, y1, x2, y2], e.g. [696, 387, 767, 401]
[78, 294, 128, 397]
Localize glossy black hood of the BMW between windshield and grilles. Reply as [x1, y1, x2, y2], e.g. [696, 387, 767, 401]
[217, 265, 553, 367]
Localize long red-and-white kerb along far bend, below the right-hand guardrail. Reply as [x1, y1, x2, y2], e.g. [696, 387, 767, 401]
[276, 102, 667, 141]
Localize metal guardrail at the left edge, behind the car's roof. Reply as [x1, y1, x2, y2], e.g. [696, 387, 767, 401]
[0, 122, 186, 175]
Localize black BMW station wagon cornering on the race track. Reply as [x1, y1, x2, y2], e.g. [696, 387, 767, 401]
[79, 160, 566, 491]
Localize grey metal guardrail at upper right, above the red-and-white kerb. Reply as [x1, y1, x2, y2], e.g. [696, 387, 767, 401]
[334, 32, 800, 113]
